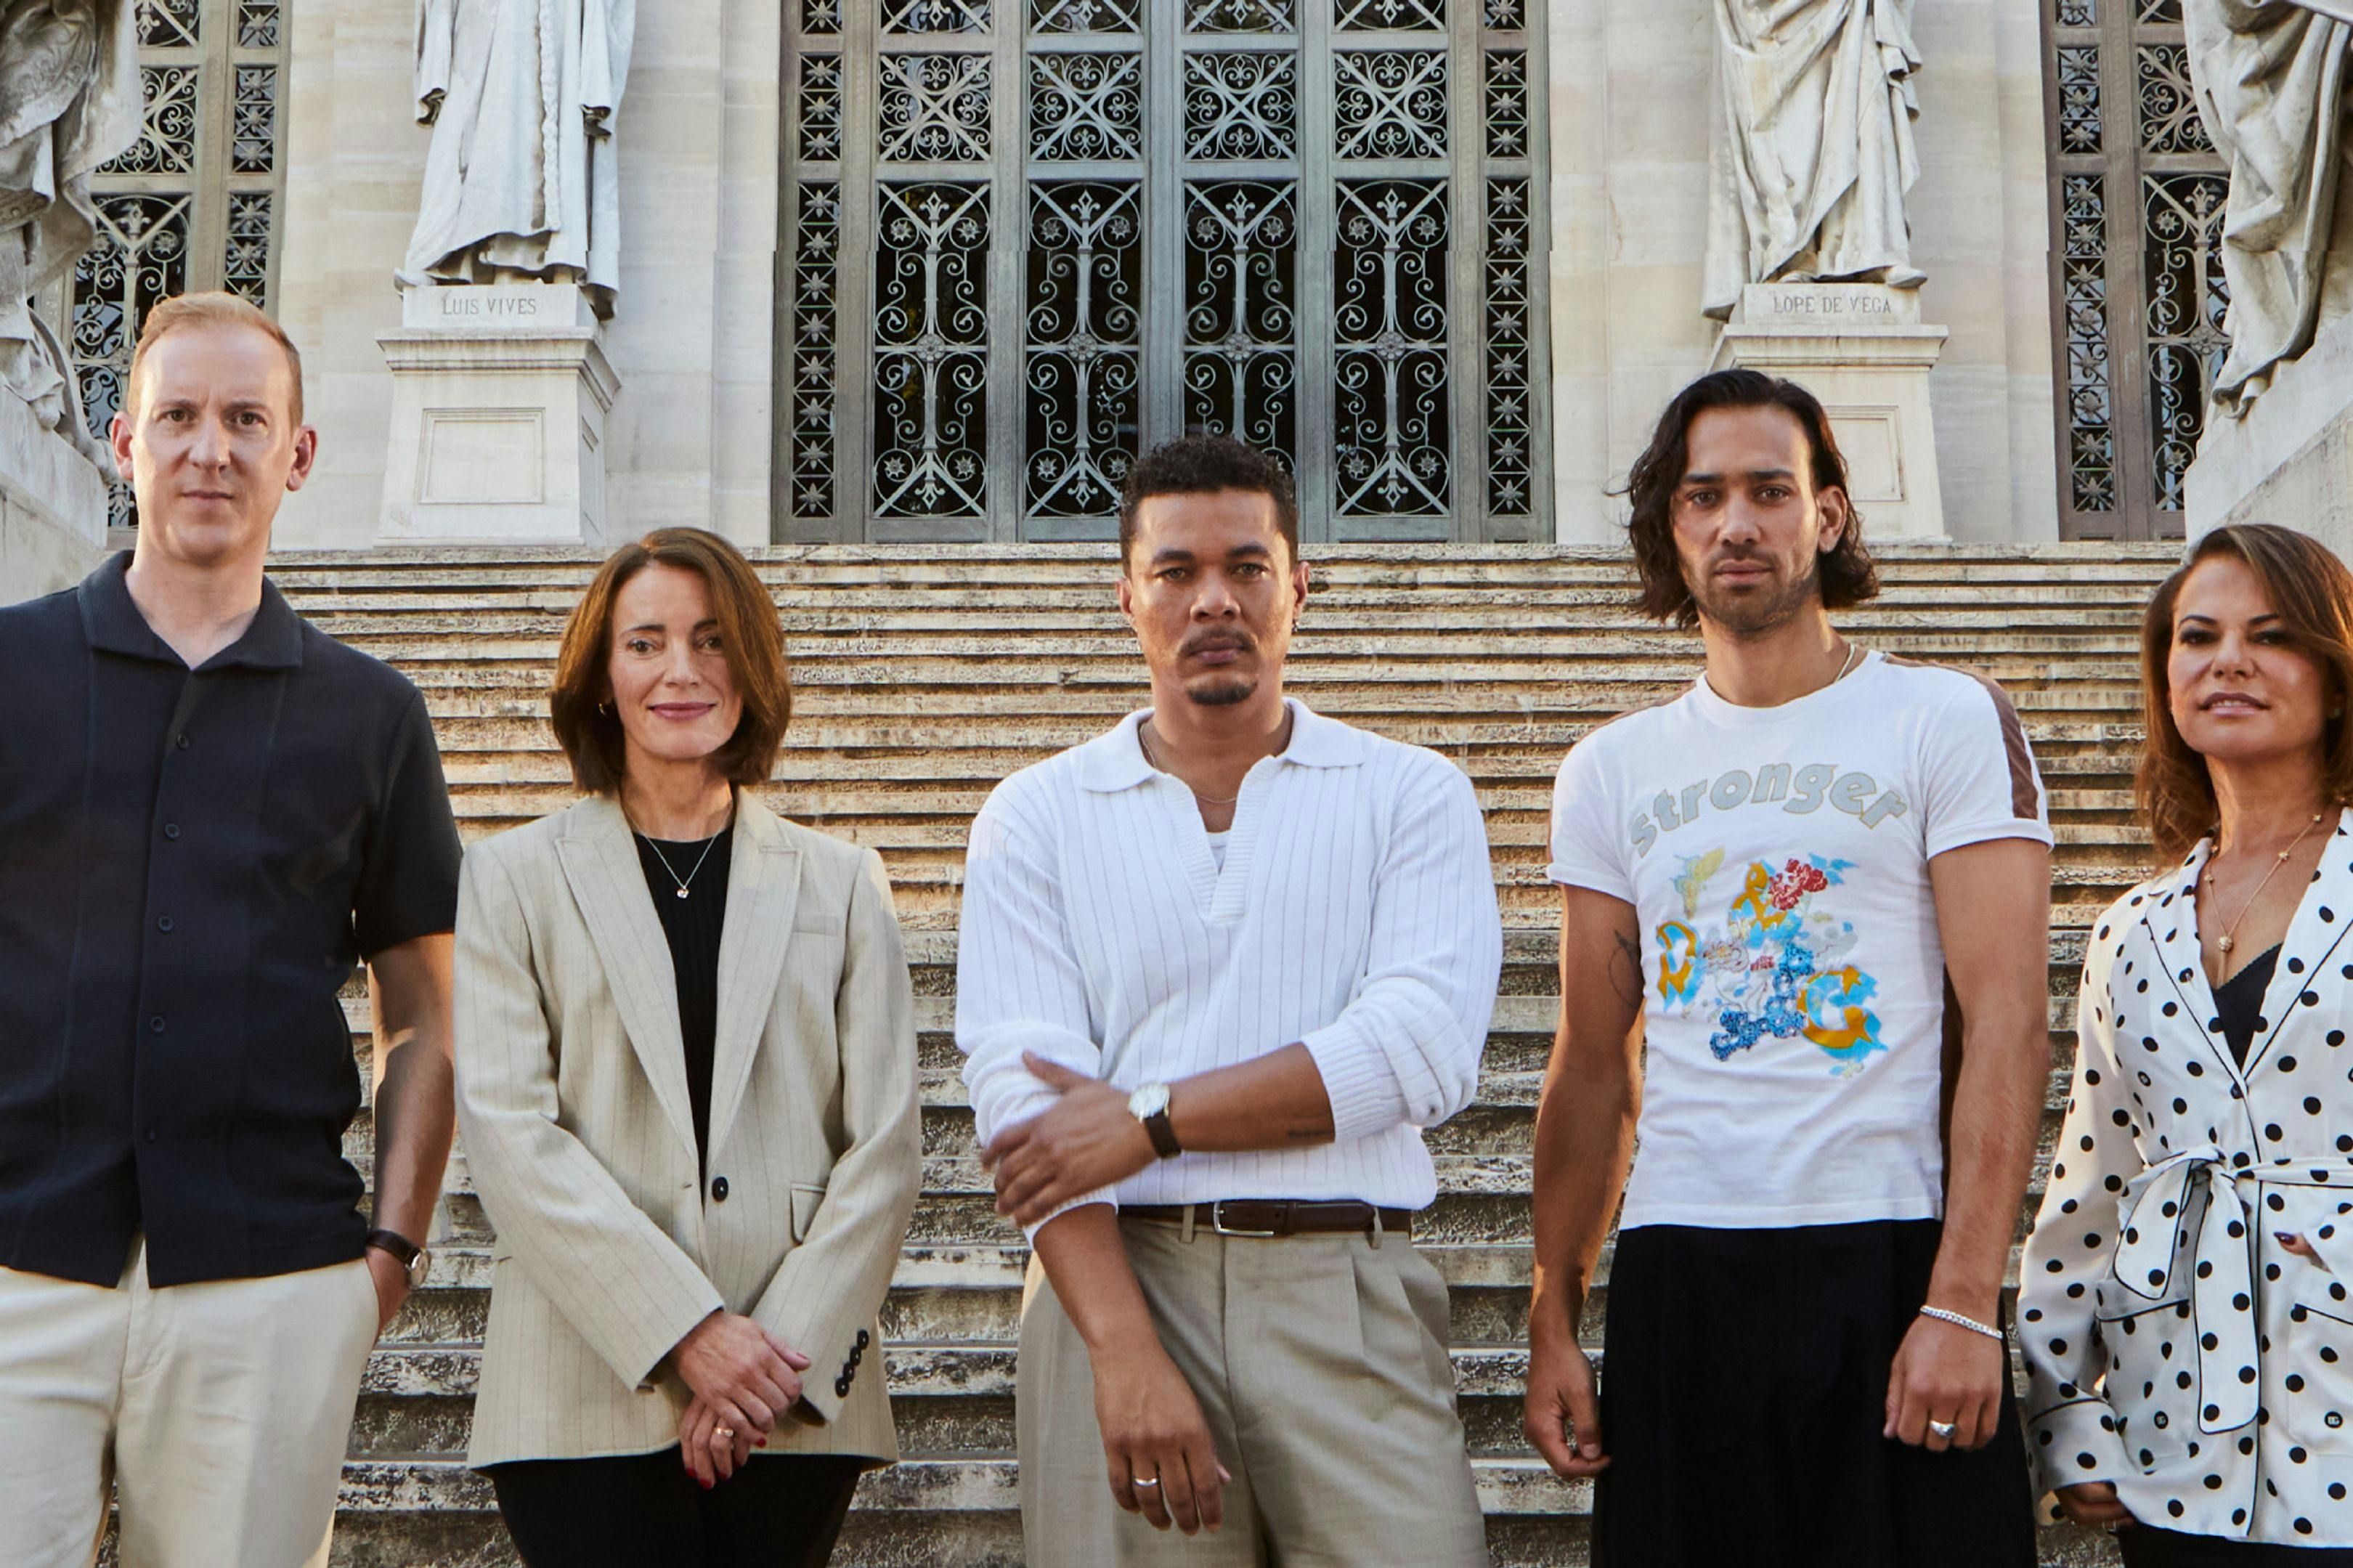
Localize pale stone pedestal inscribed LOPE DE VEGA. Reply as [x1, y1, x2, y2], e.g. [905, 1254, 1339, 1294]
[1708, 283, 1951, 542]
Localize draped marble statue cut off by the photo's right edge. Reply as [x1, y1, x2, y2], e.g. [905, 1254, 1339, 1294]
[2181, 0, 2353, 419]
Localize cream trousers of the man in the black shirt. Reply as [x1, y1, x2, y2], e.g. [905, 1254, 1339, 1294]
[0, 1246, 376, 1568]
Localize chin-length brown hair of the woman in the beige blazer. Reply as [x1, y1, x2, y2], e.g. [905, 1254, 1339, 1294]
[548, 527, 793, 796]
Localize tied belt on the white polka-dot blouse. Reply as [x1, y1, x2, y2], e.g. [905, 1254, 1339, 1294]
[2116, 1144, 2353, 1431]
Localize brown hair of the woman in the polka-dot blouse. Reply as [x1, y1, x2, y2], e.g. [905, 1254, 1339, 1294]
[2134, 523, 2353, 864]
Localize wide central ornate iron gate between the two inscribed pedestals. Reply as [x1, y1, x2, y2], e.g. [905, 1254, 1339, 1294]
[774, 0, 1553, 542]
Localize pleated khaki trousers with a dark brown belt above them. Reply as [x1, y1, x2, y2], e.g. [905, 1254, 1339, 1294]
[1014, 1219, 1487, 1568]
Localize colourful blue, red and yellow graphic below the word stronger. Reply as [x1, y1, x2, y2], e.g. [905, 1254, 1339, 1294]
[1654, 848, 1887, 1078]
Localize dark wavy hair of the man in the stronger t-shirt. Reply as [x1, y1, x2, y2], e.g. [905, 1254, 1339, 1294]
[1619, 370, 1880, 631]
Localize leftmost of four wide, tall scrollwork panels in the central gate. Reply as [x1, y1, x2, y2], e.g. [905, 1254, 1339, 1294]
[873, 182, 991, 518]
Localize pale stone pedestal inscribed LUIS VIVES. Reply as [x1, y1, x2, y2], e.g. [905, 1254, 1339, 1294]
[376, 283, 621, 544]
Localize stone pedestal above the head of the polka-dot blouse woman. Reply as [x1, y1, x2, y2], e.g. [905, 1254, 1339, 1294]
[2181, 315, 2353, 561]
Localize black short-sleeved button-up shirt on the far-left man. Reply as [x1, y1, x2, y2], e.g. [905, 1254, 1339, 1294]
[0, 556, 459, 1285]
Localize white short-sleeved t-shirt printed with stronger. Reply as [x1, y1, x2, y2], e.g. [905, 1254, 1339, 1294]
[1548, 654, 2052, 1229]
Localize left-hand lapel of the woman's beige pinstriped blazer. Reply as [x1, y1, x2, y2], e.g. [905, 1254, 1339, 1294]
[556, 798, 701, 1149]
